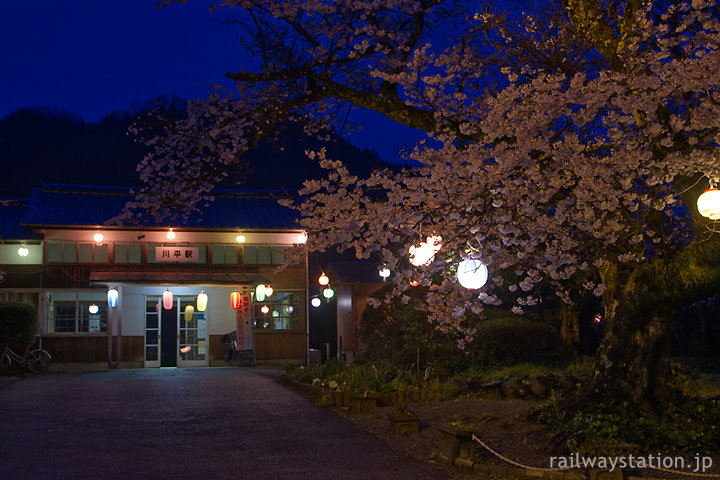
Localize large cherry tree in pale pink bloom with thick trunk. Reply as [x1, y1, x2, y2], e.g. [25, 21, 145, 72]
[128, 0, 720, 406]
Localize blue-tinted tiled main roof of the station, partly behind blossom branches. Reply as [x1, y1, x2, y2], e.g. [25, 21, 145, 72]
[21, 185, 298, 230]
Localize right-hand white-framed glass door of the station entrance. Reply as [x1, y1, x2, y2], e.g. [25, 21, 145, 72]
[178, 297, 208, 367]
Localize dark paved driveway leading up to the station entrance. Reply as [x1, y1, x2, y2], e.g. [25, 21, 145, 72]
[0, 368, 449, 480]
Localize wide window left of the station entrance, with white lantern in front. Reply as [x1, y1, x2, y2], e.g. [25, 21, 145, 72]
[45, 292, 108, 333]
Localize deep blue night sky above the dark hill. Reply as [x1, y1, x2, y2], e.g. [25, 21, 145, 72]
[0, 0, 416, 164]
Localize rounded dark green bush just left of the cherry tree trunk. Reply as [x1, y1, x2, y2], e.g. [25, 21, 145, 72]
[470, 312, 557, 365]
